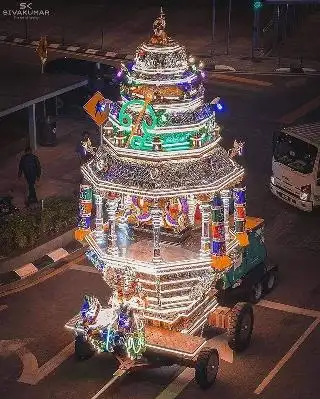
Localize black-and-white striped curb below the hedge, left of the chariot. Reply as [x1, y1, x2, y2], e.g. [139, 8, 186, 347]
[0, 241, 85, 291]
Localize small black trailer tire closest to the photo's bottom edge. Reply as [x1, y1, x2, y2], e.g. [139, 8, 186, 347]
[195, 348, 219, 389]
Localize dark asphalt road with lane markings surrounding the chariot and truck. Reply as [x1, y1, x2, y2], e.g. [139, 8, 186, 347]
[0, 70, 320, 399]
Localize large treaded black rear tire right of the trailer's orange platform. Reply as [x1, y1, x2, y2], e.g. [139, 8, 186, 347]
[228, 302, 254, 352]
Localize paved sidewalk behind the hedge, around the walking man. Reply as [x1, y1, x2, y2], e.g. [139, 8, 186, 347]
[0, 117, 98, 209]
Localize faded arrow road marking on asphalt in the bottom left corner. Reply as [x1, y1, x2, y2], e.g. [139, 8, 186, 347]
[18, 342, 74, 385]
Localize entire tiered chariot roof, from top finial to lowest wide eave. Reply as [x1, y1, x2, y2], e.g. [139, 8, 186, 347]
[82, 8, 243, 198]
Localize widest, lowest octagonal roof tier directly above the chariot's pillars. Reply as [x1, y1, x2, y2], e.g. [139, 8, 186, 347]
[83, 145, 243, 198]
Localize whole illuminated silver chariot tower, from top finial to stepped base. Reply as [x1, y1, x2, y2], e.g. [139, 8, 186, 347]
[78, 12, 247, 332]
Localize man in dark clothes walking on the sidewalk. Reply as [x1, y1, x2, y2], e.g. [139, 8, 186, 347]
[18, 147, 41, 205]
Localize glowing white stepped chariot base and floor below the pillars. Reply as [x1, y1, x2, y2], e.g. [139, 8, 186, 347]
[86, 231, 238, 331]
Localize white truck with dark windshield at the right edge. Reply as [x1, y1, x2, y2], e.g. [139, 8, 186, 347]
[270, 122, 320, 212]
